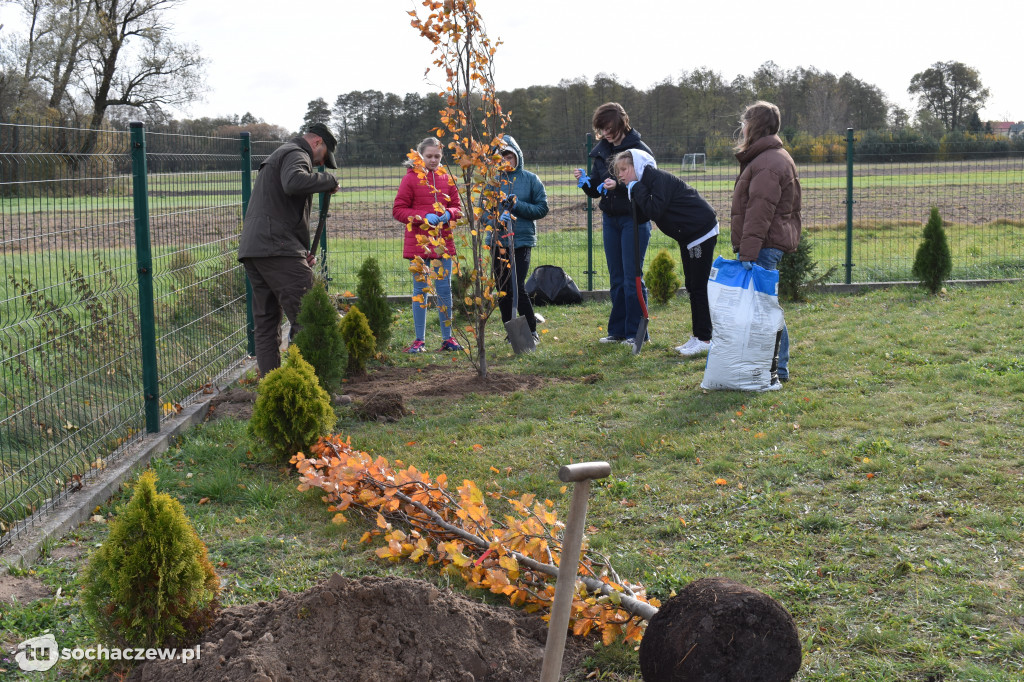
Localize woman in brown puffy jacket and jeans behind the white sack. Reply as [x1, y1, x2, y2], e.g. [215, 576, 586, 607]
[732, 101, 800, 381]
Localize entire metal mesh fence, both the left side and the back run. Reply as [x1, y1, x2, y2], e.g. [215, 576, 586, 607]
[0, 124, 1024, 550]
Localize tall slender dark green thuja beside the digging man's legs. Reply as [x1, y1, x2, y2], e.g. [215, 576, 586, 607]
[294, 282, 346, 392]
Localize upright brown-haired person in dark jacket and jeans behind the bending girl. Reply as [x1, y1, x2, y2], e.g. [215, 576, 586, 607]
[572, 101, 652, 346]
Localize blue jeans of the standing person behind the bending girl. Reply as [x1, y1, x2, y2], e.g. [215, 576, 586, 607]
[603, 213, 650, 339]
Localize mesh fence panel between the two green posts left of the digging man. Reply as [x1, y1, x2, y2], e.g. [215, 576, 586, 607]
[146, 133, 247, 404]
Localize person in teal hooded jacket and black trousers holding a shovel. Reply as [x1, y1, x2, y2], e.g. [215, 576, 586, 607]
[486, 135, 548, 340]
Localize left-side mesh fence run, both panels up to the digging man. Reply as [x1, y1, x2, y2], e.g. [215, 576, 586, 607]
[0, 124, 264, 550]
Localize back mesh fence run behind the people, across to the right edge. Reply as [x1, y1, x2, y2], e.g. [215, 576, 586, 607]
[328, 140, 1024, 295]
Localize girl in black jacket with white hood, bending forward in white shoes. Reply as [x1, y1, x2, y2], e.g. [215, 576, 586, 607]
[612, 150, 719, 357]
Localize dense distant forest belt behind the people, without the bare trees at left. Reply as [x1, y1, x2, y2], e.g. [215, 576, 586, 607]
[303, 61, 891, 162]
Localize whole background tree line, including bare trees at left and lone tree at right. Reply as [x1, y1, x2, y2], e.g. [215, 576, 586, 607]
[0, 0, 1007, 164]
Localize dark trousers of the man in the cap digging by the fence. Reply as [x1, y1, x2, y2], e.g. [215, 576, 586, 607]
[244, 255, 313, 377]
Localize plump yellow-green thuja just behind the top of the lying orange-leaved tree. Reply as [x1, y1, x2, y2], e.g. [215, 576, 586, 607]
[249, 344, 338, 460]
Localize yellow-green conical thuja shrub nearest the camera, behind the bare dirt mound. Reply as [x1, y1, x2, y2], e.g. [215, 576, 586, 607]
[82, 471, 220, 647]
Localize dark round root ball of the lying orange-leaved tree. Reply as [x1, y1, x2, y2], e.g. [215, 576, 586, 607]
[640, 578, 801, 682]
